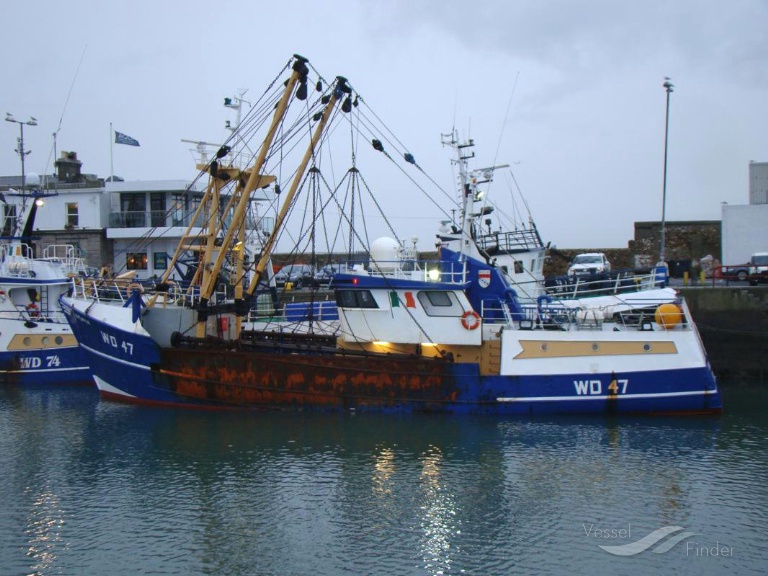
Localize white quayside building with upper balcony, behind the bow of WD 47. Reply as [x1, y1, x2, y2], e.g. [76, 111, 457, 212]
[6, 152, 274, 280]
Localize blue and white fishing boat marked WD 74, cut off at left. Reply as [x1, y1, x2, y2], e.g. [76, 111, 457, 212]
[0, 192, 92, 385]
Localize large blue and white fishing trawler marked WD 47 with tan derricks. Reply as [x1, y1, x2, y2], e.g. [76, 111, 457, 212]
[61, 56, 722, 414]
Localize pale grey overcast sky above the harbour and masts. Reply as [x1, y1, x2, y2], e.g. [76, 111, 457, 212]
[0, 0, 768, 249]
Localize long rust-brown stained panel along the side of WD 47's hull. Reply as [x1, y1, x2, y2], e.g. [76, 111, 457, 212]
[155, 349, 459, 408]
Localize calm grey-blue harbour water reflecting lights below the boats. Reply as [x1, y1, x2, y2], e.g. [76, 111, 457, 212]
[0, 384, 768, 576]
